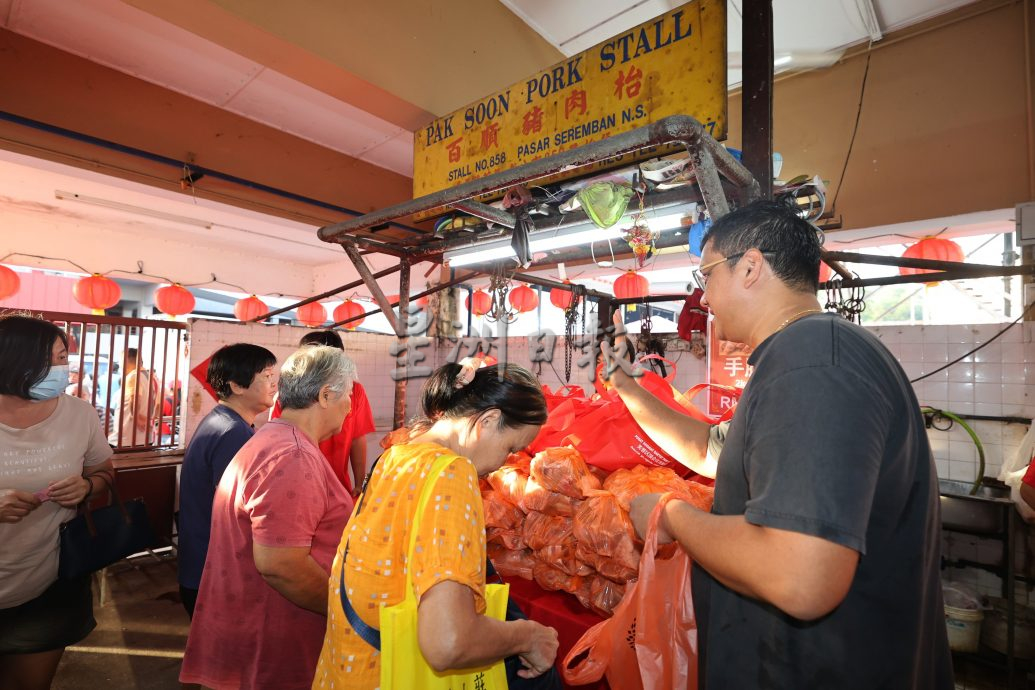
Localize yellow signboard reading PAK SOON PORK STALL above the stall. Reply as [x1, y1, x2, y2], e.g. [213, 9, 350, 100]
[413, 0, 727, 198]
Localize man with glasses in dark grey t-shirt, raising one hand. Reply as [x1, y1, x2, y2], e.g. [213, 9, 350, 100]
[605, 202, 953, 690]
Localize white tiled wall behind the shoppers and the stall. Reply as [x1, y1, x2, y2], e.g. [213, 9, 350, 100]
[186, 320, 1035, 488]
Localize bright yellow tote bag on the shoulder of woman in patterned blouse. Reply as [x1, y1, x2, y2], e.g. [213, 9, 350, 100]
[380, 455, 510, 690]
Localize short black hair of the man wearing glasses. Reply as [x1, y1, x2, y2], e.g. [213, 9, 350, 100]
[701, 200, 821, 293]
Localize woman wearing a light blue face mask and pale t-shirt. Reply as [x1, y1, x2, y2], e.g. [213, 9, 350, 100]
[0, 314, 112, 690]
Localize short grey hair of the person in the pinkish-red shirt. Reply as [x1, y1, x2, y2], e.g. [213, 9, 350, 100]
[277, 346, 356, 410]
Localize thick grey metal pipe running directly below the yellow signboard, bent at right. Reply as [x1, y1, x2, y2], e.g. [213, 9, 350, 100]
[318, 115, 753, 242]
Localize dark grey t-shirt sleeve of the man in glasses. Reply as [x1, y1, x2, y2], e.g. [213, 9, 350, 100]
[744, 365, 891, 553]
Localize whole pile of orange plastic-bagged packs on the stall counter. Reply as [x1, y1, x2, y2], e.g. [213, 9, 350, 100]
[482, 447, 712, 616]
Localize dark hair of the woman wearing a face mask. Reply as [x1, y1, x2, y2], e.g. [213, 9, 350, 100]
[0, 313, 68, 400]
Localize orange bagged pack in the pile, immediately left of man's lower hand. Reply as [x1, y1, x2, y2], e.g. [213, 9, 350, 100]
[574, 491, 640, 579]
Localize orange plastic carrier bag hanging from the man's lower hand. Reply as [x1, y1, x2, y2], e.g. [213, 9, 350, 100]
[561, 494, 698, 690]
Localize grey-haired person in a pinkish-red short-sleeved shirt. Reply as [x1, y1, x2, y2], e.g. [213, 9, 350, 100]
[180, 347, 356, 690]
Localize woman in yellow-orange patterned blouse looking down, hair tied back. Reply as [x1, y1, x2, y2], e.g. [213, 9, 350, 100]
[313, 364, 557, 690]
